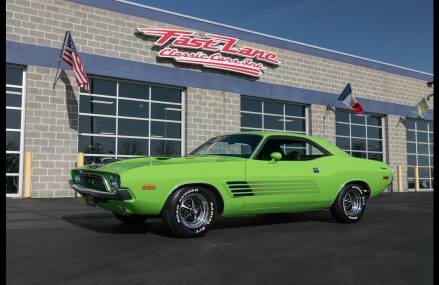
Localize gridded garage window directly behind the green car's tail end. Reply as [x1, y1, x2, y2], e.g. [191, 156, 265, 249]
[335, 110, 384, 161]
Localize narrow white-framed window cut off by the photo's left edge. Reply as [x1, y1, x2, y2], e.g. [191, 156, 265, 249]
[6, 66, 26, 197]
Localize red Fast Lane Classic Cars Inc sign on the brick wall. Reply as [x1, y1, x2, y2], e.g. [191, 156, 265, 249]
[137, 28, 280, 77]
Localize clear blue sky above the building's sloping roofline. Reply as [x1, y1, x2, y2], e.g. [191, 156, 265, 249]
[130, 0, 433, 73]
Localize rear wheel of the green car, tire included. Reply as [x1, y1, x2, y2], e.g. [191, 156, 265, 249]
[329, 184, 366, 224]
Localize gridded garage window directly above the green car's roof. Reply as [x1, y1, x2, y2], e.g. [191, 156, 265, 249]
[241, 96, 306, 134]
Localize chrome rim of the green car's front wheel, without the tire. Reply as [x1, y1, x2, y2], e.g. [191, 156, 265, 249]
[178, 193, 209, 229]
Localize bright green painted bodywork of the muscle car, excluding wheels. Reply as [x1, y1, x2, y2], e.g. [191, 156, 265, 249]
[70, 131, 393, 222]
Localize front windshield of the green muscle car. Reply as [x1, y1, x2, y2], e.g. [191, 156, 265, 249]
[189, 134, 262, 158]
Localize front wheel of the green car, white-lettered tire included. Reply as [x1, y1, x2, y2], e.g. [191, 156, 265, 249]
[162, 187, 217, 237]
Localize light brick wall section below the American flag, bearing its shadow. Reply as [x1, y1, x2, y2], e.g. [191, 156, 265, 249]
[24, 66, 79, 198]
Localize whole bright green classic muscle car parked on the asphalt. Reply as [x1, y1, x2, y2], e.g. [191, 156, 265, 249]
[68, 131, 393, 237]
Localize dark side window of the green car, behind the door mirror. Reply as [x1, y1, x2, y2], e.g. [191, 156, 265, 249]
[256, 138, 326, 161]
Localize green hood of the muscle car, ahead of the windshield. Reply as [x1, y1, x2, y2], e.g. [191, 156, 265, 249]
[85, 155, 245, 172]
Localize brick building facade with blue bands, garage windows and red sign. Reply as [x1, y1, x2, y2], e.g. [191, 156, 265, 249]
[6, 0, 433, 198]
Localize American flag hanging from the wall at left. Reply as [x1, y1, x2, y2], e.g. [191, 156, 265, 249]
[62, 32, 90, 92]
